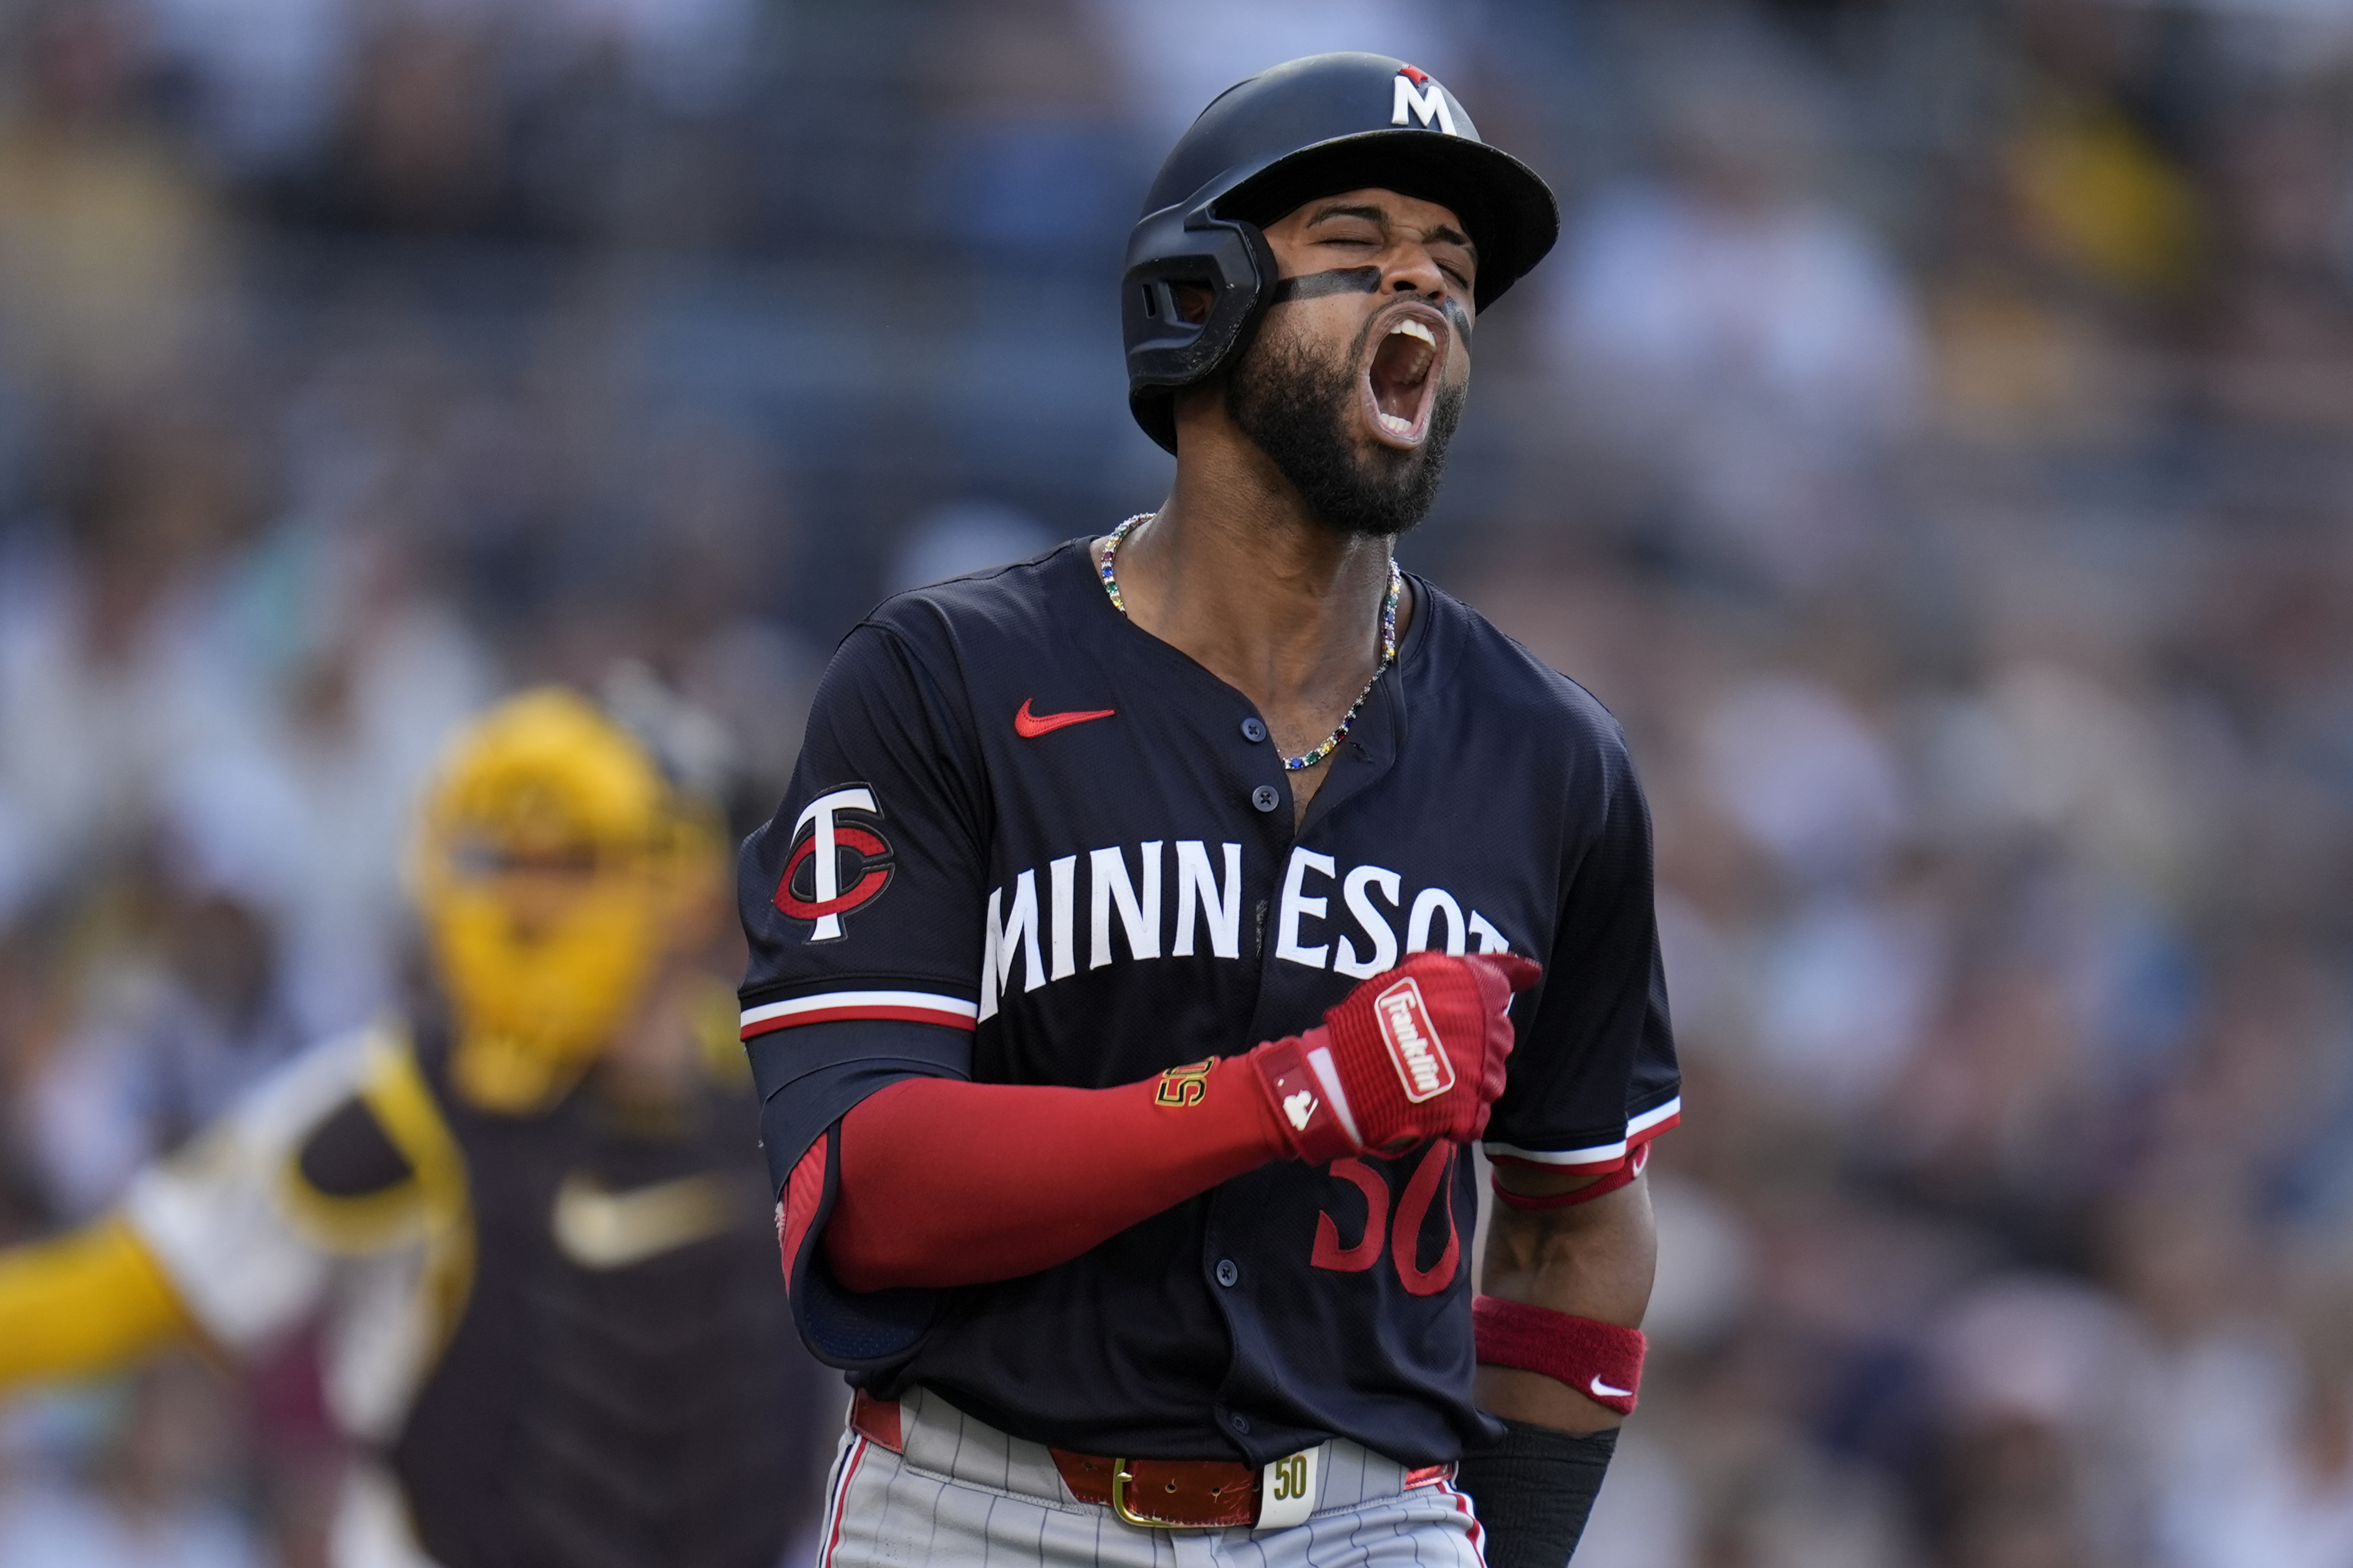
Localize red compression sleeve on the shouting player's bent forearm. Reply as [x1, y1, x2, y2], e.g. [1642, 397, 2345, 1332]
[821, 1058, 1292, 1291]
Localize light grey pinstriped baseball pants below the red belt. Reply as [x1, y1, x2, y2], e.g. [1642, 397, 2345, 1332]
[819, 1389, 1485, 1568]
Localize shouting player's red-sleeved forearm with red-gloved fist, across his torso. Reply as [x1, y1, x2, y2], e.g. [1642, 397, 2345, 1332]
[819, 952, 1541, 1291]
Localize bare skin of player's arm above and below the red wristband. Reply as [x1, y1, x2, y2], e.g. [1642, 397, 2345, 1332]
[1477, 1180, 1659, 1431]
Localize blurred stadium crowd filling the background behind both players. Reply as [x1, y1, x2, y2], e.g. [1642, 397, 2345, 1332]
[0, 0, 2353, 1568]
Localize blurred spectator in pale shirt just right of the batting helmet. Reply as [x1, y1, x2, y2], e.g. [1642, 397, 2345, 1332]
[1555, 52, 1923, 590]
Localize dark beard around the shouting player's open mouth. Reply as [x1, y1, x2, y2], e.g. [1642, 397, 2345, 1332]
[1226, 327, 1464, 536]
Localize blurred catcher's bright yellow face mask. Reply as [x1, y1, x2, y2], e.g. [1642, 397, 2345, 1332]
[414, 686, 718, 1114]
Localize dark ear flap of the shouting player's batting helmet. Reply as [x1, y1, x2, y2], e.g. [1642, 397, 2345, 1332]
[1120, 207, 1275, 451]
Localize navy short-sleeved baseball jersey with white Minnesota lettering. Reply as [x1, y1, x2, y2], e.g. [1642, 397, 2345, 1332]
[739, 543, 1680, 1465]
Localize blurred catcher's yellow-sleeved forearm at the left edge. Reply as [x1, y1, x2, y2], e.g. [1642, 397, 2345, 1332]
[0, 1220, 188, 1392]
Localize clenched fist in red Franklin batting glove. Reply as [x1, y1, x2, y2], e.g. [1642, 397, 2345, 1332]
[1249, 952, 1544, 1163]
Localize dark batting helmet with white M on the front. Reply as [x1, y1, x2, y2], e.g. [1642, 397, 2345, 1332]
[1120, 54, 1560, 451]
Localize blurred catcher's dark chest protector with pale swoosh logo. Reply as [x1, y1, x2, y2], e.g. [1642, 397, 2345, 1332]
[390, 1053, 809, 1568]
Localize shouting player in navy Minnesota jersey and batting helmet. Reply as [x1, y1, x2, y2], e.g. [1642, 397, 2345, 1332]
[739, 54, 1678, 1568]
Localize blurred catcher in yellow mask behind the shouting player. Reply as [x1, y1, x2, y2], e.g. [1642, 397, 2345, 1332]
[0, 689, 807, 1568]
